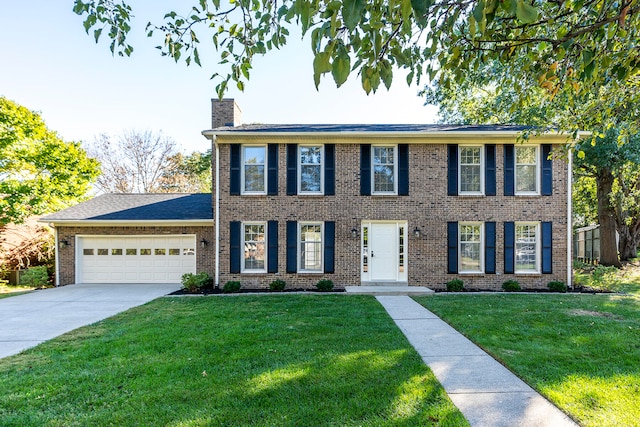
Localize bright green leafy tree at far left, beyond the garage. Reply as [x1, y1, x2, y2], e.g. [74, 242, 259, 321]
[0, 97, 99, 228]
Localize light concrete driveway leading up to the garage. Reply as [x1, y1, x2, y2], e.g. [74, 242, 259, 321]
[0, 284, 182, 358]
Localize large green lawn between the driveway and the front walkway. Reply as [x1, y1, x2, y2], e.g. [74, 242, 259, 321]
[0, 295, 467, 426]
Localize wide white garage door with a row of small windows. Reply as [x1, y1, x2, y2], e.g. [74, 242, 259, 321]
[77, 235, 196, 283]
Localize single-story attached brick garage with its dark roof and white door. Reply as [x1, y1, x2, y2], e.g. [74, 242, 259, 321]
[40, 193, 215, 285]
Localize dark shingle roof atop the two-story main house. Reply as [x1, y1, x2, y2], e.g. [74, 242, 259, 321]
[206, 124, 534, 133]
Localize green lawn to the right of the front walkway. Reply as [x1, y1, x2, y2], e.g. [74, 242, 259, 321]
[417, 294, 640, 427]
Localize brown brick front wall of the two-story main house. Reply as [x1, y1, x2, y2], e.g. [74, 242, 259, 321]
[214, 140, 567, 290]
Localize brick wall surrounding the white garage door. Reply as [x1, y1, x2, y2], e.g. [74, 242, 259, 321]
[58, 225, 215, 285]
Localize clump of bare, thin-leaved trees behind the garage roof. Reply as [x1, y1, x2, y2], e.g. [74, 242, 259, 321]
[88, 130, 211, 193]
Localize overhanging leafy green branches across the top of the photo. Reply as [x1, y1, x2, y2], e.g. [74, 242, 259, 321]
[74, 0, 640, 118]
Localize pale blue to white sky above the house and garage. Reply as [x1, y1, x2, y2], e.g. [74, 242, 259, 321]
[0, 0, 437, 153]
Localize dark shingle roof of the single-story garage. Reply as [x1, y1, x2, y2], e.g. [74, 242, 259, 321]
[40, 193, 213, 222]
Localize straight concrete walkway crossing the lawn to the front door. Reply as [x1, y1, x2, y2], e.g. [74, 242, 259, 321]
[376, 296, 577, 427]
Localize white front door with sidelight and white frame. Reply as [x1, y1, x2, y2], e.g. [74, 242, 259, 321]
[361, 221, 407, 282]
